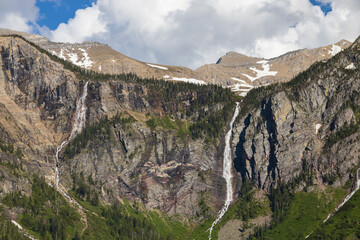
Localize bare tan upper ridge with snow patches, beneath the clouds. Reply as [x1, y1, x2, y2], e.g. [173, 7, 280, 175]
[0, 29, 350, 96]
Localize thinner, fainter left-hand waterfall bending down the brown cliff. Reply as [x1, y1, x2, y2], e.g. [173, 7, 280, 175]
[55, 82, 89, 201]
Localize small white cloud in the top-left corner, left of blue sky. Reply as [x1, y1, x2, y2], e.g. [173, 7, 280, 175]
[0, 0, 39, 32]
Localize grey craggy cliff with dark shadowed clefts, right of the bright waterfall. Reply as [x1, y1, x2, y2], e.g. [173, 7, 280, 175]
[232, 36, 360, 193]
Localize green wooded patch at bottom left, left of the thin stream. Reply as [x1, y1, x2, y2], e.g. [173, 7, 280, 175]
[2, 175, 82, 239]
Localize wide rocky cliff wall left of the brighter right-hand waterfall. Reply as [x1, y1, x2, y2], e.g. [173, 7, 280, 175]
[0, 33, 239, 236]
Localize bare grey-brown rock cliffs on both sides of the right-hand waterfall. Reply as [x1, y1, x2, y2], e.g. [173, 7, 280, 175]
[0, 30, 360, 229]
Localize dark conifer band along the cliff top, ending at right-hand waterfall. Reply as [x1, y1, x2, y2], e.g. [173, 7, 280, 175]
[3, 34, 240, 142]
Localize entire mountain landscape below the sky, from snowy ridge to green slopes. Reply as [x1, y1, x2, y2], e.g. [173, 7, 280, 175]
[0, 29, 360, 239]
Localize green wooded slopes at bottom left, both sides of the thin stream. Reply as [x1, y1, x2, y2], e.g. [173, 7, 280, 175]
[0, 171, 188, 240]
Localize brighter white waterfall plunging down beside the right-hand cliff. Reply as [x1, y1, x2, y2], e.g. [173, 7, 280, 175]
[209, 103, 240, 240]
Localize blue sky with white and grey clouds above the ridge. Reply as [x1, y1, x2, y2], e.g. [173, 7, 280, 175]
[0, 0, 360, 69]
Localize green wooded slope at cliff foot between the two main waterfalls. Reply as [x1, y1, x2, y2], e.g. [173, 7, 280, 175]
[71, 173, 188, 239]
